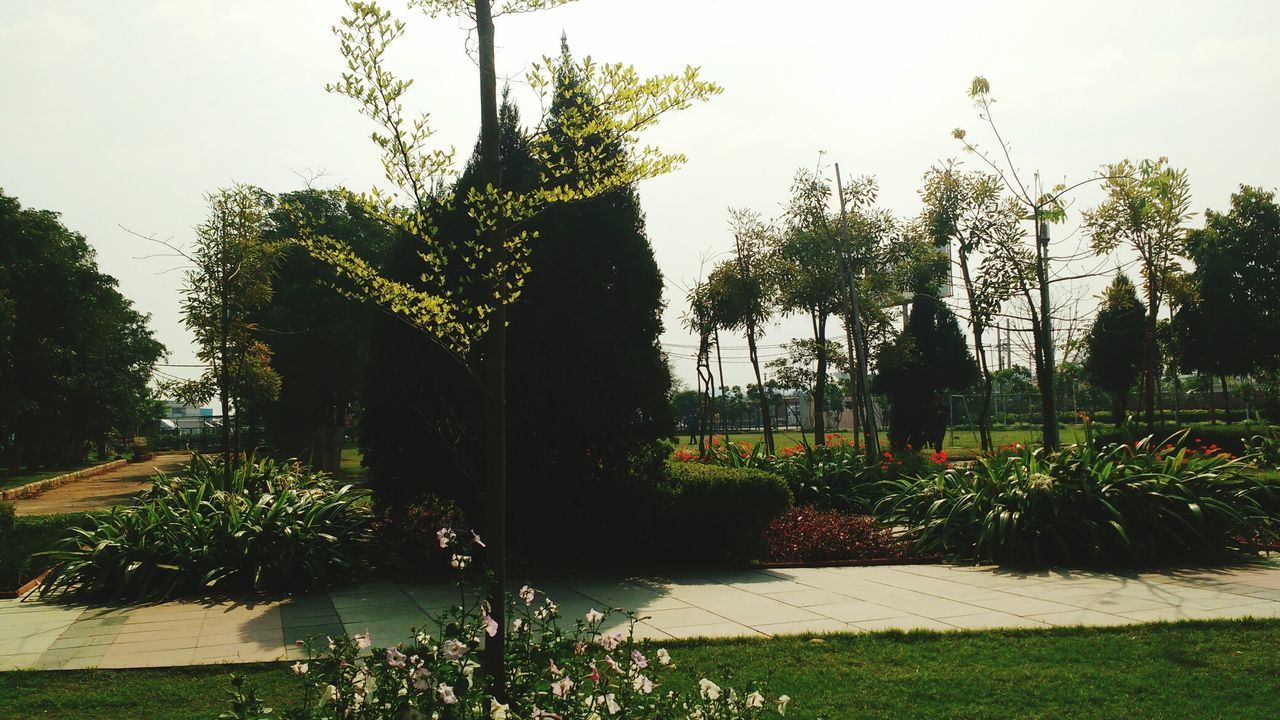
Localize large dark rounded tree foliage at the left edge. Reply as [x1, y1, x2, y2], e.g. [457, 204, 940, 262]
[0, 191, 165, 469]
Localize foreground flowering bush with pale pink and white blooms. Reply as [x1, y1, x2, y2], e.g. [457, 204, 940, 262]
[229, 530, 790, 720]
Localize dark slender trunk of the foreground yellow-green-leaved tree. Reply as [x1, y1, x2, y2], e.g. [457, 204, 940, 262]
[475, 0, 507, 702]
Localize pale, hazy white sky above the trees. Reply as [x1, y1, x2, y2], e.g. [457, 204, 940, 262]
[0, 0, 1280, 386]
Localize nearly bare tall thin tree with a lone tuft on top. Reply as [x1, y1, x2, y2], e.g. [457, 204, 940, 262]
[951, 77, 1105, 450]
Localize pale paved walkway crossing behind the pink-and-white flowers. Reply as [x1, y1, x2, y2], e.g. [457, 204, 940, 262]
[0, 560, 1280, 670]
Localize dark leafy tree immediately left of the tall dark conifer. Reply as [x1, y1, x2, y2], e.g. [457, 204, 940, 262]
[253, 190, 394, 473]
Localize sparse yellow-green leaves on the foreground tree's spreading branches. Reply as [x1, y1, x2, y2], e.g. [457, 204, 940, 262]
[298, 0, 721, 357]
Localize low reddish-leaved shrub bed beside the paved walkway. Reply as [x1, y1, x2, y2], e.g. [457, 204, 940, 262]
[765, 507, 910, 562]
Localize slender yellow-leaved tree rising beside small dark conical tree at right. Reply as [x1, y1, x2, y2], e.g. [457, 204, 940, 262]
[1084, 158, 1192, 430]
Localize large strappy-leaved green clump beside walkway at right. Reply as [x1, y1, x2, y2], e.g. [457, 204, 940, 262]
[878, 424, 1280, 565]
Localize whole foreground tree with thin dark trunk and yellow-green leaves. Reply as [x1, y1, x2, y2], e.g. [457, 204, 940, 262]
[296, 0, 719, 698]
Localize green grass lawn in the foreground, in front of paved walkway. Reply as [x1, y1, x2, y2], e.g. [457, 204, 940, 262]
[0, 620, 1280, 720]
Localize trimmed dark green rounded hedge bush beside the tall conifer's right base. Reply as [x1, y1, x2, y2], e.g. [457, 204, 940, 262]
[658, 462, 792, 561]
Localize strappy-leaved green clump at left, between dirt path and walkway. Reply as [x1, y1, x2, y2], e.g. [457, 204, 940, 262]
[41, 456, 370, 600]
